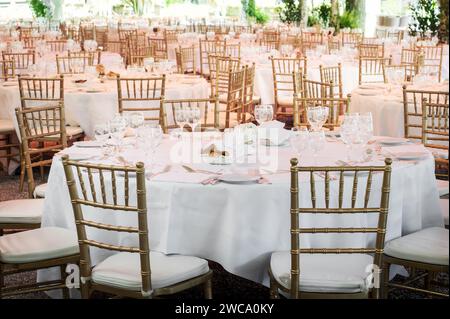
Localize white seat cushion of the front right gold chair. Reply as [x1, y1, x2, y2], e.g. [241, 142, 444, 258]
[270, 251, 373, 293]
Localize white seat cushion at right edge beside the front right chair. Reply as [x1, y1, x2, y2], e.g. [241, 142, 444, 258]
[384, 227, 448, 266]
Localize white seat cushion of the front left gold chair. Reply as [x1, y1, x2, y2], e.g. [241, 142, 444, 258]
[92, 252, 209, 291]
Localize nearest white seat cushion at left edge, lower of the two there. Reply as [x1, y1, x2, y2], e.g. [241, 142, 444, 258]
[0, 227, 79, 264]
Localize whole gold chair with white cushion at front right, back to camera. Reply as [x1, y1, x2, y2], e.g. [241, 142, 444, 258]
[269, 159, 392, 299]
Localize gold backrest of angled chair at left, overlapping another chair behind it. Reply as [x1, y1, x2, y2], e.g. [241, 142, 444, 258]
[16, 103, 67, 198]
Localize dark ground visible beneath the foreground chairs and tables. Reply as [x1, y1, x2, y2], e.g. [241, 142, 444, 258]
[0, 173, 448, 300]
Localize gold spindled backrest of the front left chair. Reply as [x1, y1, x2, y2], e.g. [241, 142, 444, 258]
[62, 156, 152, 297]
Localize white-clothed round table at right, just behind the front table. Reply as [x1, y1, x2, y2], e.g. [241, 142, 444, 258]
[350, 83, 448, 137]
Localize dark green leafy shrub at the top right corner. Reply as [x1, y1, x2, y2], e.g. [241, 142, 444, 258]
[409, 0, 440, 36]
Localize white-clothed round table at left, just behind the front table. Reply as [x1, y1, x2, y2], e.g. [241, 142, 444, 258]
[0, 74, 209, 137]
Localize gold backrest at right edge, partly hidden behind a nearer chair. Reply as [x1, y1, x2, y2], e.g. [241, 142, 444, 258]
[403, 85, 449, 140]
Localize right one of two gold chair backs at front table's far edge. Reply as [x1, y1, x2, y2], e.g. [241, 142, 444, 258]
[294, 94, 350, 131]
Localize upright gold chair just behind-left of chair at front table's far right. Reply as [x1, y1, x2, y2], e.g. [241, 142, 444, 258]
[270, 57, 308, 117]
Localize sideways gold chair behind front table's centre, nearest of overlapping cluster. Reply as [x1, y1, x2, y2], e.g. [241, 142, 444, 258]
[219, 68, 245, 129]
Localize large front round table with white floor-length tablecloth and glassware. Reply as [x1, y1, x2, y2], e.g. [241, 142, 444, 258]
[39, 137, 444, 292]
